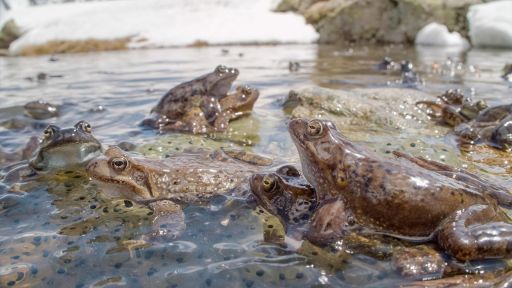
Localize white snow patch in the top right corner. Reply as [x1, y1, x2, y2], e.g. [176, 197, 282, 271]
[467, 1, 512, 48]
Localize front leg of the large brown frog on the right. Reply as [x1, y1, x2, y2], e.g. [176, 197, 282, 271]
[305, 200, 349, 246]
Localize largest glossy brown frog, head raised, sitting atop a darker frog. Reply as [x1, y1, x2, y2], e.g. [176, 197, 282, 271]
[288, 118, 512, 261]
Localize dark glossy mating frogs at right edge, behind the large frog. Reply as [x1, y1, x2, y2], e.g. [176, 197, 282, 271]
[416, 90, 512, 151]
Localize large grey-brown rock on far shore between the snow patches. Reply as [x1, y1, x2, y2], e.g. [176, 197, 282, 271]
[277, 0, 486, 43]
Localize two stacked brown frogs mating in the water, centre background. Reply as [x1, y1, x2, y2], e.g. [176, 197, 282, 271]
[142, 65, 259, 134]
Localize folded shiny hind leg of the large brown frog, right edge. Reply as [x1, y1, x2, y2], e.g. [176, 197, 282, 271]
[437, 204, 512, 261]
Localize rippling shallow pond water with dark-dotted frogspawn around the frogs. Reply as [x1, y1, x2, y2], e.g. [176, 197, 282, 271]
[0, 45, 512, 287]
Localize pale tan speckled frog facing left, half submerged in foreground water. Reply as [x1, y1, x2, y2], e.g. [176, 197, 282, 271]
[86, 146, 271, 241]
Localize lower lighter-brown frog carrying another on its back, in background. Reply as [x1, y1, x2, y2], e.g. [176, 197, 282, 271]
[158, 85, 260, 134]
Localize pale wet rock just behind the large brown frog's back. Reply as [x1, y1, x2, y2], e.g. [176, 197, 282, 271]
[284, 87, 460, 166]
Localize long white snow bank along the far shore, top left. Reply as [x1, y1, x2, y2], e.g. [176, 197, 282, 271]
[0, 0, 318, 54]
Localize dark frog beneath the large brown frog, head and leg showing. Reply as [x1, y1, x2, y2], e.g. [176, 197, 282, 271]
[250, 165, 447, 279]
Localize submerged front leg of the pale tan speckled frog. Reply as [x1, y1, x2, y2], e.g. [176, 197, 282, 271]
[148, 200, 186, 241]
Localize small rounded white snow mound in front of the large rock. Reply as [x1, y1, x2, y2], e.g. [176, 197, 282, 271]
[415, 22, 469, 49]
